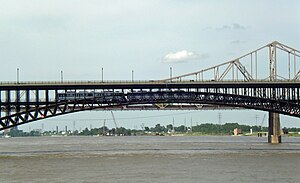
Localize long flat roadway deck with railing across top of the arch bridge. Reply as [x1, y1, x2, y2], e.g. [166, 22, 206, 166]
[0, 80, 300, 90]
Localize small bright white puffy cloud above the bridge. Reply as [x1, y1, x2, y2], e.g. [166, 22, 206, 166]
[163, 50, 208, 63]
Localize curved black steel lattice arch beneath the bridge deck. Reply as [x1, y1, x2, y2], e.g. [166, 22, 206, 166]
[0, 91, 300, 130]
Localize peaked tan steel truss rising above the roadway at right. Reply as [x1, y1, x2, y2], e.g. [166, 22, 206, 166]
[162, 41, 300, 82]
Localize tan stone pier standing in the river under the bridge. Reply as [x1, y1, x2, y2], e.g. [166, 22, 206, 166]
[268, 112, 281, 144]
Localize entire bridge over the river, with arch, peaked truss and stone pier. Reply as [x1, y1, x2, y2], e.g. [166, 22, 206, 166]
[0, 41, 300, 143]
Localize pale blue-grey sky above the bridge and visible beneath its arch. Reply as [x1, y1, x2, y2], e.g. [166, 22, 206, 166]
[0, 0, 300, 132]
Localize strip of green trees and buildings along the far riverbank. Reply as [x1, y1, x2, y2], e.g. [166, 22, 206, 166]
[4, 123, 300, 137]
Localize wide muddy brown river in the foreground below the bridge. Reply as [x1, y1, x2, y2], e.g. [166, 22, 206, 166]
[0, 136, 300, 183]
